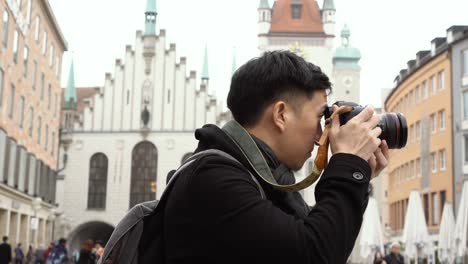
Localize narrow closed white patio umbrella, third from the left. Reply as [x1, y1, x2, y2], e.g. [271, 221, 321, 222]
[438, 202, 455, 263]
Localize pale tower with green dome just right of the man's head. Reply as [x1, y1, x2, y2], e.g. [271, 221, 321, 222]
[330, 25, 361, 103]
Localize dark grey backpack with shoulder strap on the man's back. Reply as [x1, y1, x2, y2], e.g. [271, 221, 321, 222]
[99, 149, 265, 264]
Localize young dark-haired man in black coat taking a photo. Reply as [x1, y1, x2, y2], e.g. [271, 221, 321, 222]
[164, 51, 388, 264]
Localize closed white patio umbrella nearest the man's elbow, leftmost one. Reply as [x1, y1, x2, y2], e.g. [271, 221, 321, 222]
[359, 197, 384, 259]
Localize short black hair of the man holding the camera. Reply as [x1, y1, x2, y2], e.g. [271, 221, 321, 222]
[227, 51, 331, 126]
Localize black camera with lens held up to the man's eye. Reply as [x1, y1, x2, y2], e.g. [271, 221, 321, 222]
[324, 101, 408, 149]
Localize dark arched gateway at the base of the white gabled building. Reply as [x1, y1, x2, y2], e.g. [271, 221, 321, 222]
[68, 221, 114, 255]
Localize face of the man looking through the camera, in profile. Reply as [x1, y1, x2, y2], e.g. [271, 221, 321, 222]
[276, 91, 327, 170]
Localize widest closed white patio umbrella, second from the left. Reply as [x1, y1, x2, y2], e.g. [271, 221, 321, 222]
[402, 191, 433, 263]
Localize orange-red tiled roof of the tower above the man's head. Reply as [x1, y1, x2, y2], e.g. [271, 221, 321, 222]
[270, 0, 324, 33]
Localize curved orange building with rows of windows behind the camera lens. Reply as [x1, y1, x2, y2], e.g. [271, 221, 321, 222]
[385, 27, 467, 241]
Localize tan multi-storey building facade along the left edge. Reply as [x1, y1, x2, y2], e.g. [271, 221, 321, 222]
[0, 0, 67, 249]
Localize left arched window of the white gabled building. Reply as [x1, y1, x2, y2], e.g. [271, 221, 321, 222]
[88, 153, 109, 209]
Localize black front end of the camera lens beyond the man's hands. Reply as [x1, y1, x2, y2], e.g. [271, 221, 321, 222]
[377, 113, 408, 149]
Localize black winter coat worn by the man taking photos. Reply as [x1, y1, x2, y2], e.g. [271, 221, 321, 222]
[164, 125, 371, 264]
